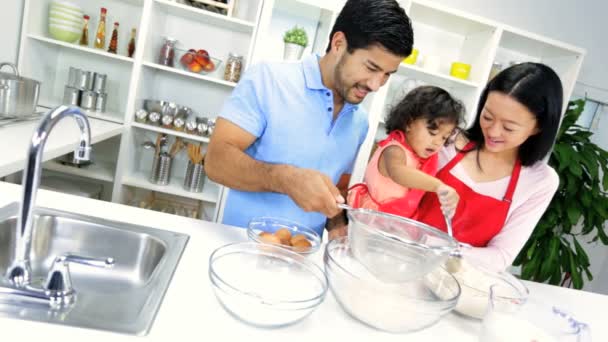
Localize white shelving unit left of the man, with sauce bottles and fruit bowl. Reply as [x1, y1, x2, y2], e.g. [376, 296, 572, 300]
[18, 0, 263, 220]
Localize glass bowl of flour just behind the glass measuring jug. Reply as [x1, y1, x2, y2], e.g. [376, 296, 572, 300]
[452, 258, 529, 319]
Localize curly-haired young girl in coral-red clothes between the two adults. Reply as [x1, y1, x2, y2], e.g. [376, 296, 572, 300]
[347, 86, 464, 217]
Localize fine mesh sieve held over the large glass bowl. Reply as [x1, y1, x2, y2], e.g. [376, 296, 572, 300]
[347, 209, 458, 283]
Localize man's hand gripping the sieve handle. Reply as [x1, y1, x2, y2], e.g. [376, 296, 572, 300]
[279, 166, 344, 217]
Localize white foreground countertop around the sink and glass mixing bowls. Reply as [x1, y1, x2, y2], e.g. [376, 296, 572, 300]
[0, 182, 608, 342]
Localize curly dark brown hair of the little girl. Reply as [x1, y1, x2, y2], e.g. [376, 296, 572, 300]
[385, 86, 464, 133]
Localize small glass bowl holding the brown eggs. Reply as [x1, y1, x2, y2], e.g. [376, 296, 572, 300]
[247, 217, 321, 254]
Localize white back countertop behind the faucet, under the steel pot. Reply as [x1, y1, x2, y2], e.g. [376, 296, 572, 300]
[0, 118, 123, 177]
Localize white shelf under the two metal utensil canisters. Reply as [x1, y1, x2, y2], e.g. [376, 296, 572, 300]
[123, 170, 219, 203]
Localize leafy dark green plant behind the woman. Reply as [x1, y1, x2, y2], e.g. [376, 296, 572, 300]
[513, 100, 608, 289]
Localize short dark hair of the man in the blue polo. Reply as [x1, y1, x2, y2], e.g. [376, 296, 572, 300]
[326, 0, 414, 57]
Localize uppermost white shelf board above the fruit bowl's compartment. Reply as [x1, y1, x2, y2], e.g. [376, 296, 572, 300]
[155, 0, 255, 33]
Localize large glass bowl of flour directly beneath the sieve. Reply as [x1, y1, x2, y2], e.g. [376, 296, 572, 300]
[323, 237, 460, 333]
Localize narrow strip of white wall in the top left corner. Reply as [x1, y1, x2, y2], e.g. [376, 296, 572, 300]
[0, 0, 24, 66]
